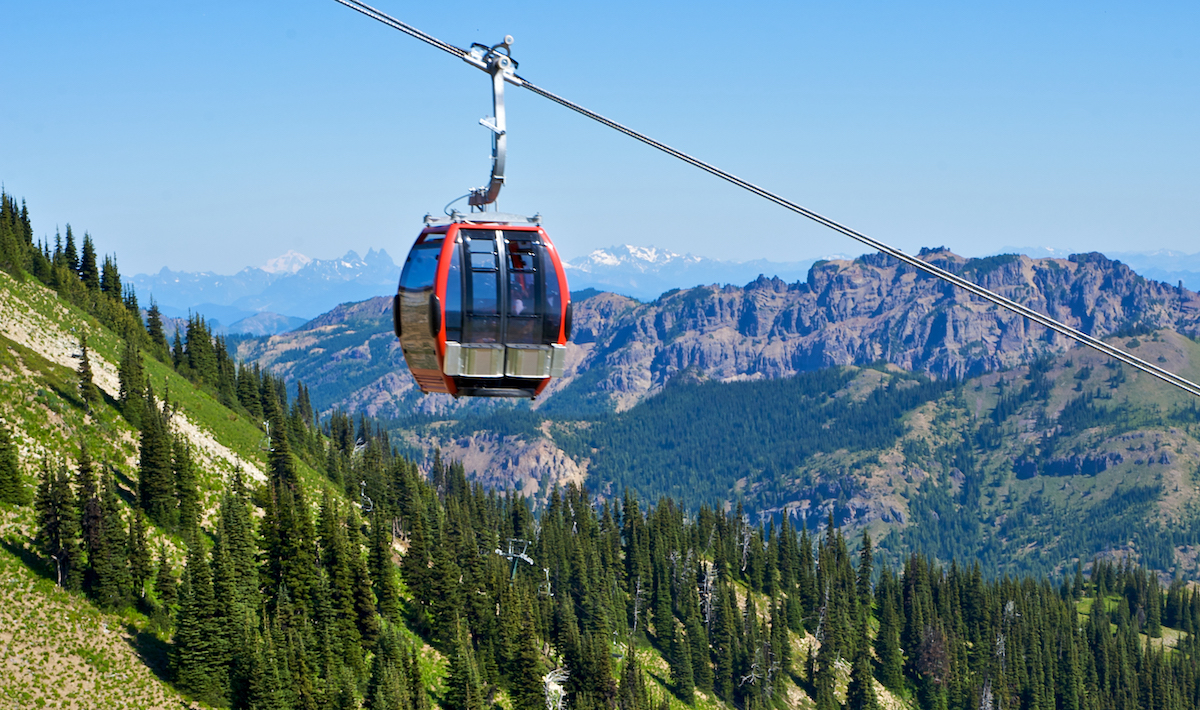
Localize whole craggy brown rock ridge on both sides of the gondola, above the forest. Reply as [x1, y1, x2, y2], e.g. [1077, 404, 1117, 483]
[238, 249, 1200, 417]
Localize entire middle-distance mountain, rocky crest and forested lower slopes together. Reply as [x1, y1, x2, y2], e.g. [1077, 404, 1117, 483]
[226, 236, 1200, 574]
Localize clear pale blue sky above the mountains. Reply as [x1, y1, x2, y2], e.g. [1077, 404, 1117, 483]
[0, 0, 1200, 273]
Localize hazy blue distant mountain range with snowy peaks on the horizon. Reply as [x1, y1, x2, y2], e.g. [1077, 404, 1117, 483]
[132, 245, 1200, 336]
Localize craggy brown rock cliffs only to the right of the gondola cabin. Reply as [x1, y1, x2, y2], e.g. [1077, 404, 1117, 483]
[557, 249, 1200, 409]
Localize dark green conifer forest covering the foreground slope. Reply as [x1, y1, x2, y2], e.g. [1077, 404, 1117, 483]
[7, 183, 1200, 710]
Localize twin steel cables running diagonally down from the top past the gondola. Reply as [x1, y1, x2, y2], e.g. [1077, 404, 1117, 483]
[336, 0, 1200, 397]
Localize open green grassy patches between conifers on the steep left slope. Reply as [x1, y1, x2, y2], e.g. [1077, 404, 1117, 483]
[0, 273, 336, 708]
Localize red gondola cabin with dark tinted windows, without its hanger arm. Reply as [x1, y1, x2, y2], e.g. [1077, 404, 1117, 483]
[392, 212, 571, 397]
